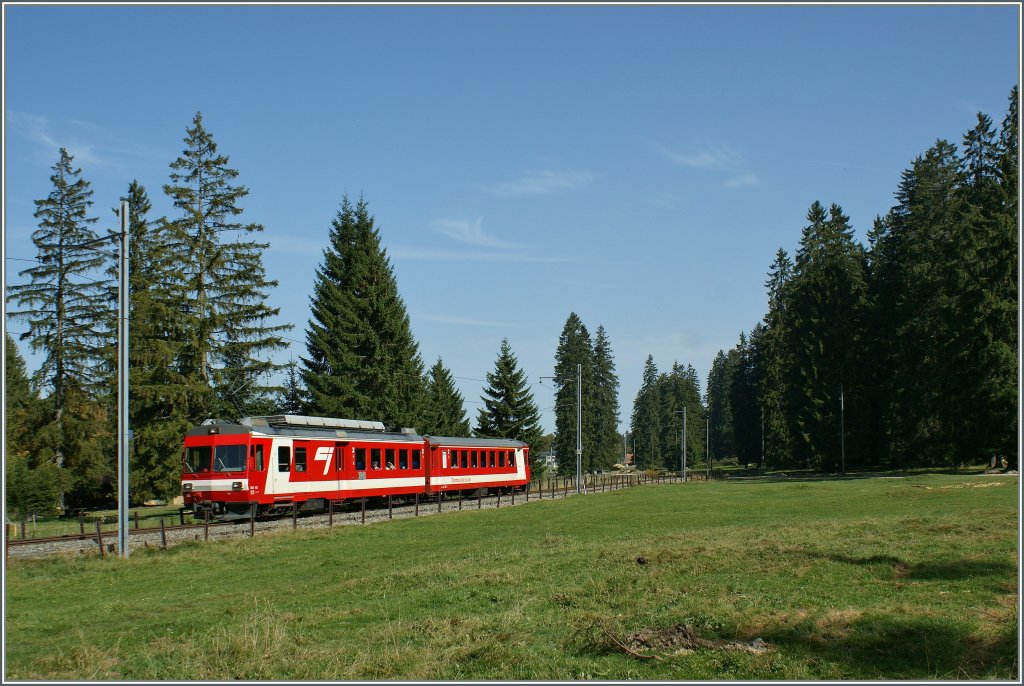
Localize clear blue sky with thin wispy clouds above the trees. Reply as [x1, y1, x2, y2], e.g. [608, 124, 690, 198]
[3, 4, 1020, 431]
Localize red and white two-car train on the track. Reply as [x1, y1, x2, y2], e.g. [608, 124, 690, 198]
[181, 415, 529, 519]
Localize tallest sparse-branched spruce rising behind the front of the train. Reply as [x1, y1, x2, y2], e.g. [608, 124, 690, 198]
[164, 113, 291, 422]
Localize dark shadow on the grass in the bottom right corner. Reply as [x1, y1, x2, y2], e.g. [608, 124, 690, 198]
[760, 613, 1019, 681]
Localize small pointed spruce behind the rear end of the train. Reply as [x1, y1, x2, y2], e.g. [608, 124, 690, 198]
[473, 338, 543, 445]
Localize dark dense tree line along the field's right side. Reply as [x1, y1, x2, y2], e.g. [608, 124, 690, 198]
[708, 87, 1019, 471]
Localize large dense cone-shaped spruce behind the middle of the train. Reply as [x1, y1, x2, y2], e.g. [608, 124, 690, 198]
[301, 196, 424, 427]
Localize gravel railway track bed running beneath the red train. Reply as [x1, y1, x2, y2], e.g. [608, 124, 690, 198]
[6, 483, 647, 557]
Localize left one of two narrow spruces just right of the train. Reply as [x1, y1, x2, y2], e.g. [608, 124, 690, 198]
[554, 312, 598, 476]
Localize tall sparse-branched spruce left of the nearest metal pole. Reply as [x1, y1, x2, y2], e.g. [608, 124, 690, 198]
[7, 147, 114, 508]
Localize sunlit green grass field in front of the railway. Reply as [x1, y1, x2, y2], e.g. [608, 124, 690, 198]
[5, 475, 1019, 681]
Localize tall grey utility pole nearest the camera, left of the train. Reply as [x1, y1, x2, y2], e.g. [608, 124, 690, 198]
[118, 200, 131, 558]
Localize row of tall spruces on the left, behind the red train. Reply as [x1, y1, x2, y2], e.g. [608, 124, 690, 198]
[4, 114, 589, 513]
